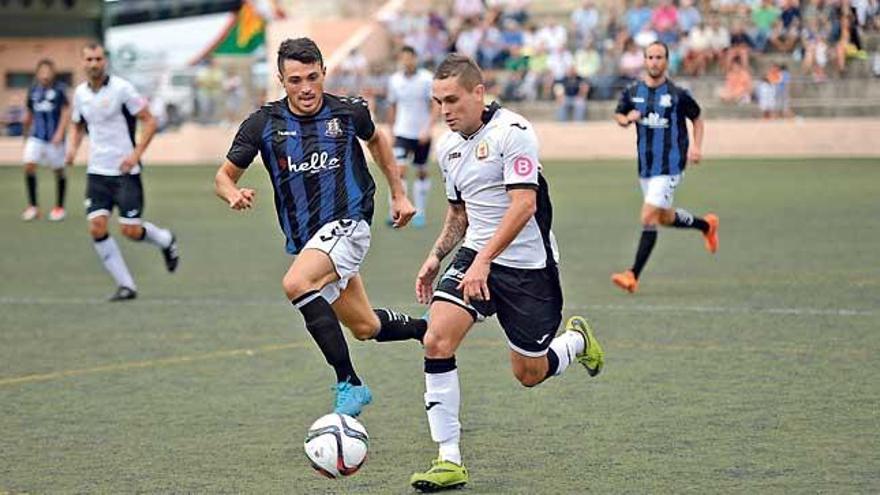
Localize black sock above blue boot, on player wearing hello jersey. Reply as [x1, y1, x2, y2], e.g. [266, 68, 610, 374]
[291, 291, 361, 386]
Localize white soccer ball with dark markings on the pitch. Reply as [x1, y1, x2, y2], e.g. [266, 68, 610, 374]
[303, 413, 370, 478]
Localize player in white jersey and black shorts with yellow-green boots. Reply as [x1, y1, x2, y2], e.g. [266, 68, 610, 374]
[410, 54, 604, 491]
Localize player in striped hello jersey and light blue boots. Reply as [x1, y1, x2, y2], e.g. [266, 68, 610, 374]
[215, 38, 427, 416]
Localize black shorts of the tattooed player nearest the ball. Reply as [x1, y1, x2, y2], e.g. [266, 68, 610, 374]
[433, 248, 562, 357]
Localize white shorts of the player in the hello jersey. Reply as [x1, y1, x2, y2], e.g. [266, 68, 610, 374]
[303, 220, 370, 303]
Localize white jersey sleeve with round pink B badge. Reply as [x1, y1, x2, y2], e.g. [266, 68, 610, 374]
[501, 122, 541, 189]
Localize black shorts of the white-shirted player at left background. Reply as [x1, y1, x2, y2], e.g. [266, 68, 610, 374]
[86, 174, 144, 225]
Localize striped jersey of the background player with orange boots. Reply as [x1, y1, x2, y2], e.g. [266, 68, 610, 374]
[615, 80, 700, 178]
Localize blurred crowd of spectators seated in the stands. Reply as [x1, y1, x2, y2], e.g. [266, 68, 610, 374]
[326, 0, 880, 120]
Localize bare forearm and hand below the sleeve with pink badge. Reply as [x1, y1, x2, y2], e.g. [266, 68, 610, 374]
[458, 189, 538, 303]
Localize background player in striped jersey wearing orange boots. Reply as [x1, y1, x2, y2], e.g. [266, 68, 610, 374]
[611, 42, 718, 293]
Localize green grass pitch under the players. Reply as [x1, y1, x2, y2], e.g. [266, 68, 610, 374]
[0, 159, 880, 494]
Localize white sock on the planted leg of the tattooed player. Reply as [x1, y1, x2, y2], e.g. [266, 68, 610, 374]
[425, 369, 461, 465]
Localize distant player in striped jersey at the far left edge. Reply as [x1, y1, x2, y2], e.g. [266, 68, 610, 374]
[21, 59, 70, 222]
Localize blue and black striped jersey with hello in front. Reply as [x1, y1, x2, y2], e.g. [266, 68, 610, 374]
[226, 93, 376, 254]
